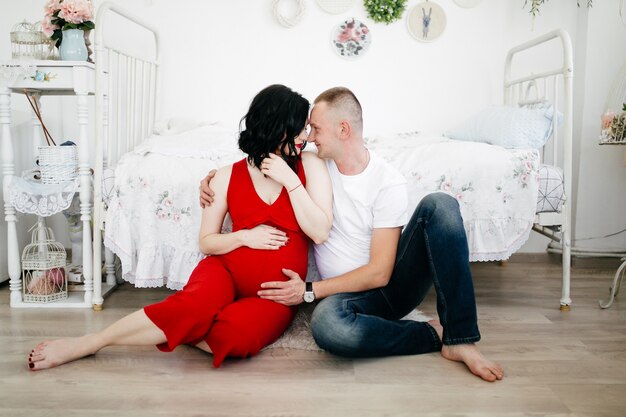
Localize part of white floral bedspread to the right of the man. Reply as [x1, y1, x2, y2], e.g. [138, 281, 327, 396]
[367, 133, 539, 261]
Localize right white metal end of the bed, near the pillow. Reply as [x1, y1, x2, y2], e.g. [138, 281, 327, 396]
[504, 29, 574, 310]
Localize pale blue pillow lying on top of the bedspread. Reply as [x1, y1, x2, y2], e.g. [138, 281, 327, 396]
[445, 104, 554, 149]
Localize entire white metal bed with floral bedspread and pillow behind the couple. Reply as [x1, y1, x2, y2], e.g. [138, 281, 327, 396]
[94, 3, 572, 310]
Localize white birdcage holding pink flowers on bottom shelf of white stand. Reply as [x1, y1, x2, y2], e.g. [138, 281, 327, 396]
[22, 221, 67, 303]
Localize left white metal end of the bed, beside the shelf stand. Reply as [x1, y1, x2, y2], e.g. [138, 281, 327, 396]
[93, 2, 159, 310]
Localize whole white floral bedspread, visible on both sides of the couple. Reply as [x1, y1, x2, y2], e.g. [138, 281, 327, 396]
[105, 126, 539, 289]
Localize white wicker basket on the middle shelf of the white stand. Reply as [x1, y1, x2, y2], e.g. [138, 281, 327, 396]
[39, 146, 78, 184]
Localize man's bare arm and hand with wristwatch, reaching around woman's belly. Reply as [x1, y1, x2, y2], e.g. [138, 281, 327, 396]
[258, 227, 402, 305]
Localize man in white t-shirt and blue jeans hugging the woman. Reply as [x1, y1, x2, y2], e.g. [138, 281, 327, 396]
[201, 87, 504, 382]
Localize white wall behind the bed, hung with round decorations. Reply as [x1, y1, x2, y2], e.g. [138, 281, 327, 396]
[0, 0, 626, 278]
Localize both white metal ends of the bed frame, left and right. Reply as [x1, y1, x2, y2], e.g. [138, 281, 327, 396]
[93, 2, 573, 310]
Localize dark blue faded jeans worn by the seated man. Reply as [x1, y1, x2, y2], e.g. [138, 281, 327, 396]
[311, 193, 480, 357]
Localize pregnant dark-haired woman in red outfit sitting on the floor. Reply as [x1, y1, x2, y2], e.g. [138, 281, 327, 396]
[28, 85, 332, 370]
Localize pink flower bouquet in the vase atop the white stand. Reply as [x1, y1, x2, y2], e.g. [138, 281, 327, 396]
[41, 0, 96, 48]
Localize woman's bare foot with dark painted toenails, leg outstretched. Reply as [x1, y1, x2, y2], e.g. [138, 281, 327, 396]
[28, 336, 95, 371]
